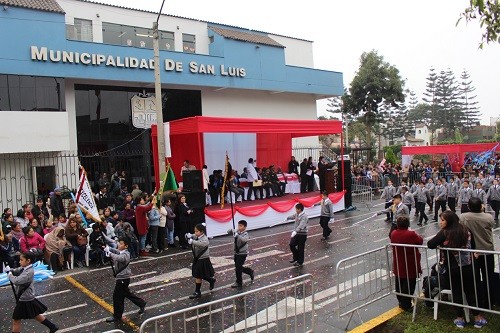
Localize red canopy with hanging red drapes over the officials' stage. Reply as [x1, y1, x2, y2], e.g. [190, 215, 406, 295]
[170, 116, 342, 182]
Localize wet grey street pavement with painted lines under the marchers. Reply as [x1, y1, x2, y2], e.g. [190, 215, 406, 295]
[0, 198, 498, 332]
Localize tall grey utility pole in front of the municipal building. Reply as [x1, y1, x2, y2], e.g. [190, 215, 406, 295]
[153, 0, 167, 175]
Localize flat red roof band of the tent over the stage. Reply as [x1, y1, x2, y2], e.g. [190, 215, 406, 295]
[170, 116, 342, 138]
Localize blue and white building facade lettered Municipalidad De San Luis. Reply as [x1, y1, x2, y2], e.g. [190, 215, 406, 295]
[0, 0, 343, 207]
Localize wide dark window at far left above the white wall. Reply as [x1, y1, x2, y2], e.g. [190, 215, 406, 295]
[0, 75, 65, 111]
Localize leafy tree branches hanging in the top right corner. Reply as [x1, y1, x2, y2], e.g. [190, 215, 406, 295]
[457, 0, 500, 48]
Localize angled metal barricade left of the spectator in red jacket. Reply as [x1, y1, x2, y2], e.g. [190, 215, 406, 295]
[335, 247, 392, 329]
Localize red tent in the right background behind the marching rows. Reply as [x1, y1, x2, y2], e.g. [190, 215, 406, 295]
[401, 142, 500, 166]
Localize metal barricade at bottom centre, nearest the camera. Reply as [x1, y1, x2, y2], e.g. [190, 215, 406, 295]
[139, 274, 315, 333]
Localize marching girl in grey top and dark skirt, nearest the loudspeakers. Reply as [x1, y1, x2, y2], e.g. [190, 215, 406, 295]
[186, 224, 216, 299]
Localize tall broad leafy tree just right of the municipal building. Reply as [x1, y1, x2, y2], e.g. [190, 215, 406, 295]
[342, 50, 405, 160]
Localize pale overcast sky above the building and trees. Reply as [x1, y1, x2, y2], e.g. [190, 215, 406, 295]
[95, 0, 500, 124]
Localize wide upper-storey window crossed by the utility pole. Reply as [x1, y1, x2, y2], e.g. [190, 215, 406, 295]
[102, 22, 175, 51]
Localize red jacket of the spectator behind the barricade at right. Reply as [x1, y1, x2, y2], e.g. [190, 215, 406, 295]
[390, 229, 424, 279]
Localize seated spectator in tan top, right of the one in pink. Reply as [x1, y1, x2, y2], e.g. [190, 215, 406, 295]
[45, 227, 73, 272]
